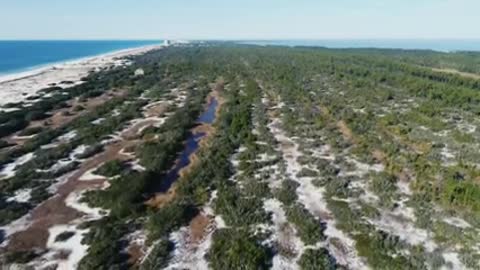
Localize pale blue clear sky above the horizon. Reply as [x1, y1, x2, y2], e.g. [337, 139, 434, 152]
[0, 0, 480, 39]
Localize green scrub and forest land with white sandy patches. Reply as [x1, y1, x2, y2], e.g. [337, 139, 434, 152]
[0, 43, 480, 270]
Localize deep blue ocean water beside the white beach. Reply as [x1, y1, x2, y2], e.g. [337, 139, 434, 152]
[0, 40, 162, 74]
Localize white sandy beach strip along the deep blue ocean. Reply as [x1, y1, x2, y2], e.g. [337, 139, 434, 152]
[0, 43, 166, 108]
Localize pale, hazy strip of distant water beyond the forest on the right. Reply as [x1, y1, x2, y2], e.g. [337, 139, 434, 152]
[240, 39, 480, 52]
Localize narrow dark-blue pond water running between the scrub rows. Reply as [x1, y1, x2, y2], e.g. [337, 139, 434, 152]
[157, 97, 218, 192]
